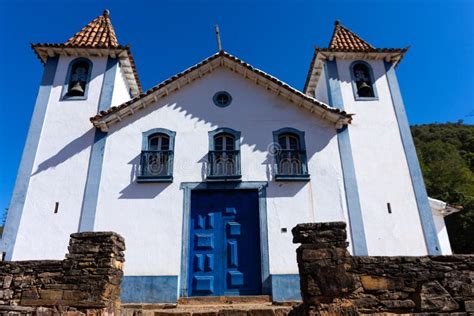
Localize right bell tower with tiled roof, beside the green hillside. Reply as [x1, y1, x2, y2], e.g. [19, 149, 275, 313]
[304, 21, 441, 256]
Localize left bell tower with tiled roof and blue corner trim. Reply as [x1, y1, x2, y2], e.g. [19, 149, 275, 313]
[0, 10, 141, 260]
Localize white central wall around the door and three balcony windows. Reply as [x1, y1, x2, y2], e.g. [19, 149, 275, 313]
[95, 68, 346, 275]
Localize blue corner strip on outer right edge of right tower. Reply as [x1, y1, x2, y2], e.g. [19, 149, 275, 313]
[384, 62, 441, 255]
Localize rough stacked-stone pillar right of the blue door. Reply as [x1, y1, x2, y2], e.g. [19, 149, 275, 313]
[292, 222, 356, 315]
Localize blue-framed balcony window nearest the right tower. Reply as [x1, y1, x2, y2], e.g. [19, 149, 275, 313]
[273, 128, 309, 181]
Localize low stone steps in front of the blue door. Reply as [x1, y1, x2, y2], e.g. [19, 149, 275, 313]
[121, 295, 300, 316]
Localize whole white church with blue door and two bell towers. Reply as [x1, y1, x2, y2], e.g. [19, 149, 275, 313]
[1, 11, 458, 302]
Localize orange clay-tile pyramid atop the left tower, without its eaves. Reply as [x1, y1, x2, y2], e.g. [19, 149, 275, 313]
[65, 10, 119, 48]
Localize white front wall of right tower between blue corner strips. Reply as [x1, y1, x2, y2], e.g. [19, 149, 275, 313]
[337, 60, 427, 256]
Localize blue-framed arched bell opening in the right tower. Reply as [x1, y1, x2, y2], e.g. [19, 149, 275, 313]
[350, 61, 378, 101]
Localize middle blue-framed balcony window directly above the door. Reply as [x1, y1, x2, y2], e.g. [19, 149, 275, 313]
[207, 128, 241, 180]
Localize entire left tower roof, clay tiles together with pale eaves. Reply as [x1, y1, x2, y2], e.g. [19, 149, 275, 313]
[31, 10, 143, 96]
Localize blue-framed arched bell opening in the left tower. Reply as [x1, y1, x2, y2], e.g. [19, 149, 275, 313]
[62, 57, 92, 100]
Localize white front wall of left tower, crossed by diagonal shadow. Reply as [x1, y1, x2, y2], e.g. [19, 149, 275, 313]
[12, 57, 107, 260]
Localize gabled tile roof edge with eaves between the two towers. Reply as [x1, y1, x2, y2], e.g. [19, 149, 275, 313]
[90, 51, 352, 131]
